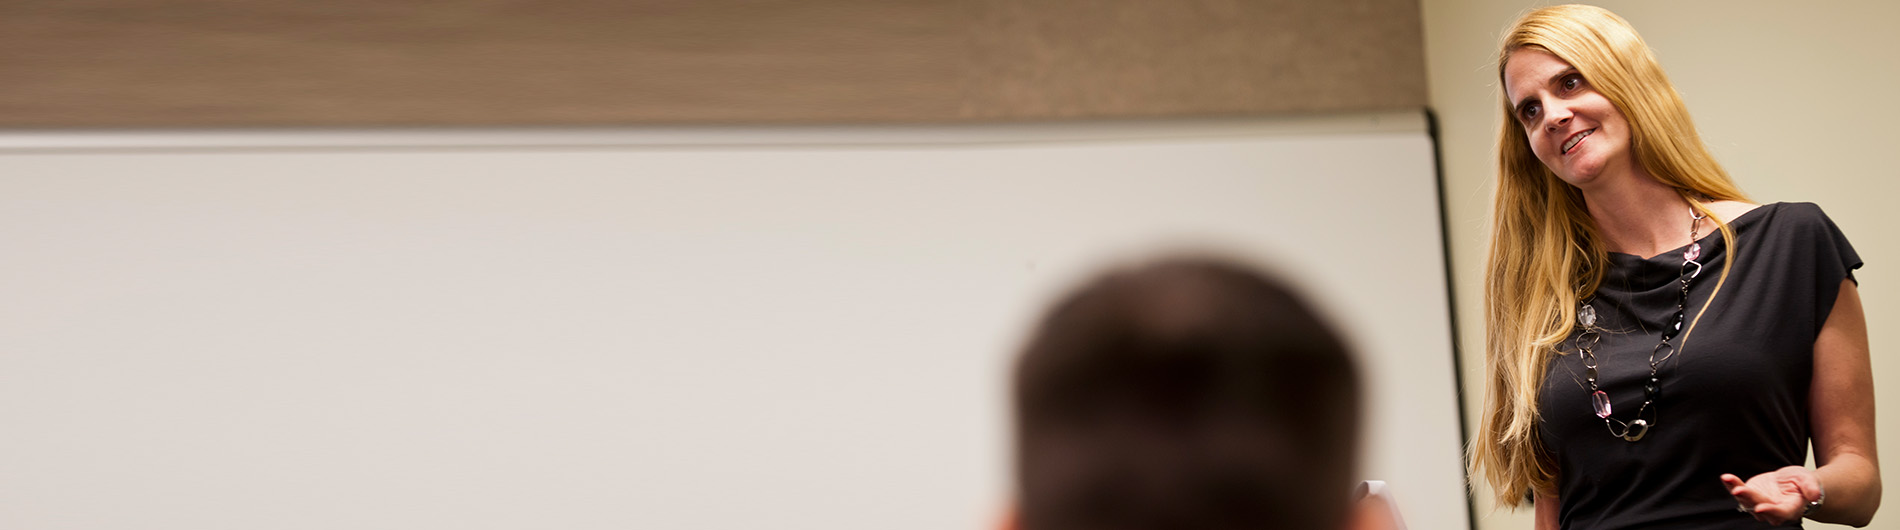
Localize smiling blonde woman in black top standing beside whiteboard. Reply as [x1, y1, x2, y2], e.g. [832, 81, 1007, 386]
[1471, 6, 1881, 528]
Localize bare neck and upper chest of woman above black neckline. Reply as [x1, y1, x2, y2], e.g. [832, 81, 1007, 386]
[1583, 171, 1708, 258]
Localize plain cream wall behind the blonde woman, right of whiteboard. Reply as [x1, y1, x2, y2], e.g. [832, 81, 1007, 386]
[1421, 0, 1900, 530]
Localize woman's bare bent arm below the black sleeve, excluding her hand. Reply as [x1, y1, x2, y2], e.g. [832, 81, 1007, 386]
[1807, 279, 1881, 526]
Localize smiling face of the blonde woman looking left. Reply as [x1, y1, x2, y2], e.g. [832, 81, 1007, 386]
[1505, 47, 1634, 188]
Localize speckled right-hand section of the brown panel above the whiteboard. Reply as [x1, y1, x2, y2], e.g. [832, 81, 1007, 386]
[961, 0, 1425, 118]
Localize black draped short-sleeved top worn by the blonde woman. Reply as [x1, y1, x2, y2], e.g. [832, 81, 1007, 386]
[1537, 203, 1860, 530]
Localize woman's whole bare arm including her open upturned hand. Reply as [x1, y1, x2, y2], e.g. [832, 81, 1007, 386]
[1721, 279, 1881, 526]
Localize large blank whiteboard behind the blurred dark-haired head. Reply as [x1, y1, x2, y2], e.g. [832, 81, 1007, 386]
[0, 114, 1469, 530]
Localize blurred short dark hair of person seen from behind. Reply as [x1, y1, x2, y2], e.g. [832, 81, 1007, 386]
[1015, 258, 1360, 530]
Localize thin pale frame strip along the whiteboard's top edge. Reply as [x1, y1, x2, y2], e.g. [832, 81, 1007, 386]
[0, 110, 1431, 154]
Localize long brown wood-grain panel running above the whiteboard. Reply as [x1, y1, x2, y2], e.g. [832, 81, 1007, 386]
[0, 0, 1425, 127]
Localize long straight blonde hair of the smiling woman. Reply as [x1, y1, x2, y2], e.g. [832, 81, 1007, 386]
[1471, 6, 1746, 507]
